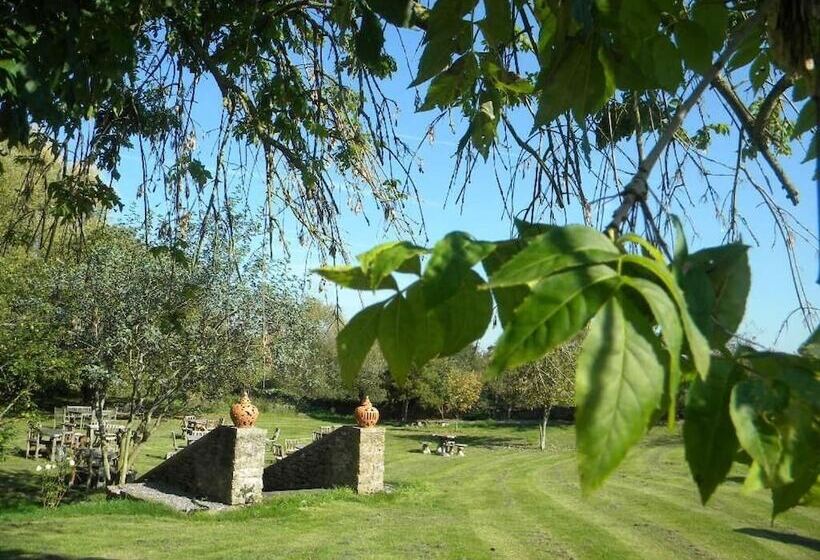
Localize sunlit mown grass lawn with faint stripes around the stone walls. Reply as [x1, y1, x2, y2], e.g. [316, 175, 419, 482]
[0, 414, 820, 560]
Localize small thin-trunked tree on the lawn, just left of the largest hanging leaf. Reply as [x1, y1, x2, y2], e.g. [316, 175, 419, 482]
[497, 339, 581, 451]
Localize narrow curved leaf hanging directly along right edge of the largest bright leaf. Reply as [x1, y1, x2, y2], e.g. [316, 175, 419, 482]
[623, 276, 683, 428]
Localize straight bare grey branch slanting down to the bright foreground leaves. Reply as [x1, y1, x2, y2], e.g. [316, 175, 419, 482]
[605, 11, 761, 235]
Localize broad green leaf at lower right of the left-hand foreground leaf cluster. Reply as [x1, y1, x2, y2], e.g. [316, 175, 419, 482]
[430, 270, 493, 356]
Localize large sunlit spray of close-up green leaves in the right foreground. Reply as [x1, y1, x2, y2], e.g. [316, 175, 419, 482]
[319, 223, 820, 514]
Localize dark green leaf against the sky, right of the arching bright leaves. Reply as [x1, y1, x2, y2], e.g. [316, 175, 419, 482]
[685, 244, 752, 346]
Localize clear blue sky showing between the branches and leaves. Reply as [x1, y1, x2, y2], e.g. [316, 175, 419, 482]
[112, 28, 820, 351]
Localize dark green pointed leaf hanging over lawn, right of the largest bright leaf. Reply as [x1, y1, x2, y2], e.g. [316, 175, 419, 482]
[683, 359, 740, 504]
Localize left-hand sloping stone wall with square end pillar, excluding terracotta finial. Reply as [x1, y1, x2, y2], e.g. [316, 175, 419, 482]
[139, 426, 267, 505]
